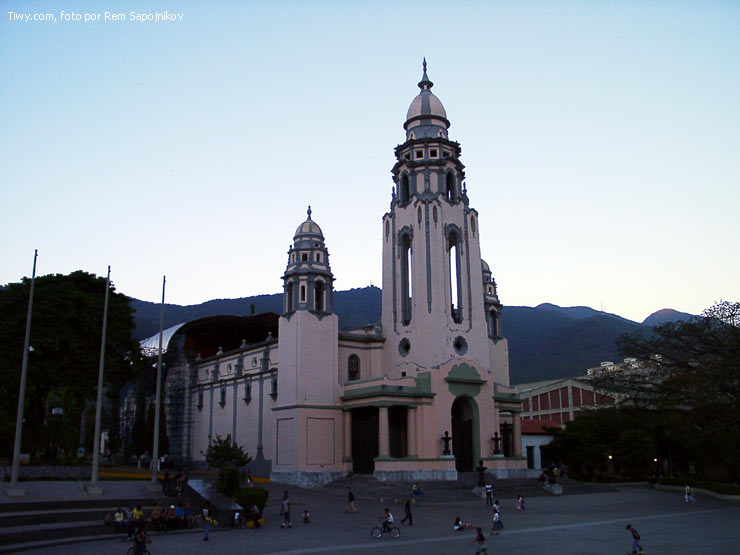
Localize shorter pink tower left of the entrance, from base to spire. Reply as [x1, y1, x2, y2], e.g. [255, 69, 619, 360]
[272, 206, 343, 485]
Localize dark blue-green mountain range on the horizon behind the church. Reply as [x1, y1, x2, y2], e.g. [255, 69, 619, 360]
[132, 286, 691, 384]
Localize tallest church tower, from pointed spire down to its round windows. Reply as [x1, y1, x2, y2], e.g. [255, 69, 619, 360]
[382, 60, 498, 377]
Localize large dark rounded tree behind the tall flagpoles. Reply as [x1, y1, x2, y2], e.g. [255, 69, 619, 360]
[0, 271, 140, 460]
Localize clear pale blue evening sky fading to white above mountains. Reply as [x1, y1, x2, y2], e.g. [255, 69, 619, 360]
[0, 0, 740, 321]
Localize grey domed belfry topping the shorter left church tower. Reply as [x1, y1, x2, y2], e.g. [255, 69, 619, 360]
[283, 206, 334, 315]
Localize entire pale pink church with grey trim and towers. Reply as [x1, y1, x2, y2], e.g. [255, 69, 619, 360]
[166, 62, 526, 485]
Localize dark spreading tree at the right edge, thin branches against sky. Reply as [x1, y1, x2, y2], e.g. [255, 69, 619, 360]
[593, 301, 740, 480]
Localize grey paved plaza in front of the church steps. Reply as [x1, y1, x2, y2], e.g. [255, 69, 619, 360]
[17, 484, 740, 555]
